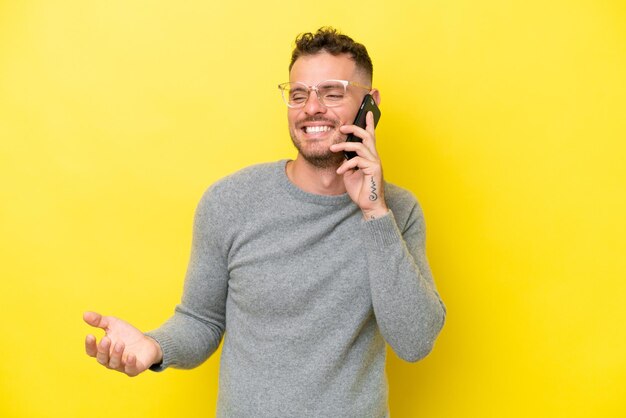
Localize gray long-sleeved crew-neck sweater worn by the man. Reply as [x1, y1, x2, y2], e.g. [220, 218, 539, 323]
[147, 161, 445, 418]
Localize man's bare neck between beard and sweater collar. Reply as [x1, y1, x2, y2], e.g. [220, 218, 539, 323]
[285, 155, 346, 196]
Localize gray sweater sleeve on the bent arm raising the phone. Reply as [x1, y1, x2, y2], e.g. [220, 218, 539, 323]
[363, 199, 446, 362]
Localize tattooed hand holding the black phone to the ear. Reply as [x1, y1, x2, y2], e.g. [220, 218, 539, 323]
[330, 112, 389, 219]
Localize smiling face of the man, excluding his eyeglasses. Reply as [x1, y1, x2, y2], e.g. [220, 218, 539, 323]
[287, 52, 370, 168]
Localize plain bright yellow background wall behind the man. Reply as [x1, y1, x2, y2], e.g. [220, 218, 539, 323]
[0, 0, 626, 418]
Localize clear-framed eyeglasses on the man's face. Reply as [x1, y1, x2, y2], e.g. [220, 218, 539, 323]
[278, 80, 372, 108]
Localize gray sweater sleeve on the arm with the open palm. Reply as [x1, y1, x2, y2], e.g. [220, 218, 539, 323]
[146, 188, 228, 371]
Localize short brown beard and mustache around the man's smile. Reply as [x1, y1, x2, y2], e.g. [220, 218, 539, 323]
[289, 117, 346, 168]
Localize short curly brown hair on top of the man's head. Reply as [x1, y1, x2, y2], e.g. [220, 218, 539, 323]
[289, 26, 374, 80]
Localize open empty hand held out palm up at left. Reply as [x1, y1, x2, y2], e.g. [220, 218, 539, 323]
[83, 312, 163, 377]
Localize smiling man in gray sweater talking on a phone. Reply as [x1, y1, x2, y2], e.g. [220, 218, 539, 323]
[84, 28, 445, 417]
